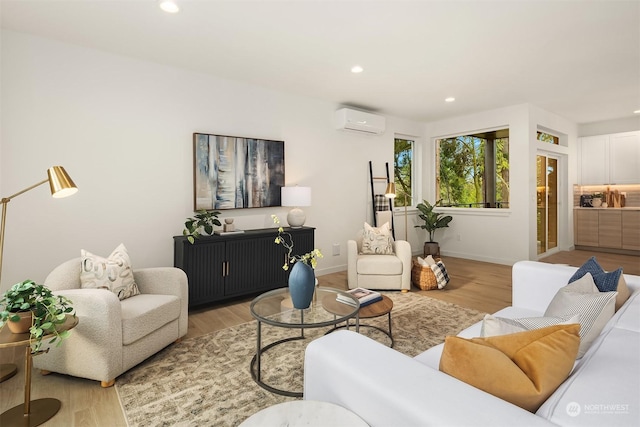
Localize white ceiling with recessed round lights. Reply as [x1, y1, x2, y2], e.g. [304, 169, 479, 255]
[0, 0, 640, 123]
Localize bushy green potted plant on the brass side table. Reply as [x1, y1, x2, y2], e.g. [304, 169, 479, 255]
[0, 280, 75, 353]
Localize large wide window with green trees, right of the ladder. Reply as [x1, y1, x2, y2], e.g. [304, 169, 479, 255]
[436, 129, 509, 208]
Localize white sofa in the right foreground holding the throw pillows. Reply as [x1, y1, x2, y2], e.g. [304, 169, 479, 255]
[304, 261, 640, 427]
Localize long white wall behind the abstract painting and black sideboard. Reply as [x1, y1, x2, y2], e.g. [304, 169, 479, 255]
[0, 31, 424, 290]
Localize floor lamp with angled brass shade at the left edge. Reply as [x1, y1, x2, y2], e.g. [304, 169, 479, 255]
[0, 166, 78, 382]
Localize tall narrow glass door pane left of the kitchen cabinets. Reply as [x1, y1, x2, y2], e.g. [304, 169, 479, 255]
[536, 154, 558, 255]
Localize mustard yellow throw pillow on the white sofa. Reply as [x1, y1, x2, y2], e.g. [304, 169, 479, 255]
[440, 323, 580, 412]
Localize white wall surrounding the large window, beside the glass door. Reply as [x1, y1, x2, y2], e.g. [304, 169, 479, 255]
[423, 104, 576, 265]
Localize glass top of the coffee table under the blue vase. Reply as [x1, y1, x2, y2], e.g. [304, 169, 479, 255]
[251, 287, 360, 328]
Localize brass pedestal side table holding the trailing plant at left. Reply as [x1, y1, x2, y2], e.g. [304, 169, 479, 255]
[0, 315, 78, 427]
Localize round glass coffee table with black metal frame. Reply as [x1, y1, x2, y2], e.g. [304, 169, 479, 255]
[250, 287, 360, 397]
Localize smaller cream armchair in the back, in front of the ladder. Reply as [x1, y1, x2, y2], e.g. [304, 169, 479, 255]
[347, 230, 411, 292]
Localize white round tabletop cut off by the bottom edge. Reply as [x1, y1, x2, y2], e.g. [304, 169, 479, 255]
[240, 400, 368, 427]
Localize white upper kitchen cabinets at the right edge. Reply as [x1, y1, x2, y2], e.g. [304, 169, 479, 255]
[578, 131, 640, 185]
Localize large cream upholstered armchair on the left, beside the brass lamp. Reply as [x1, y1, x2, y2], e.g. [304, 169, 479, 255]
[33, 258, 189, 387]
